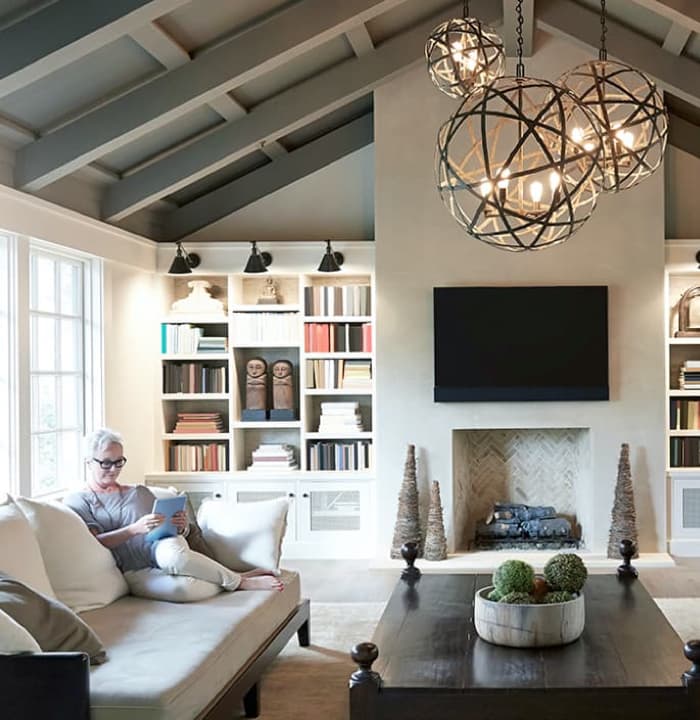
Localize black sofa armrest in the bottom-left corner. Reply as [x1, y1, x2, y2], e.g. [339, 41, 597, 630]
[0, 652, 90, 720]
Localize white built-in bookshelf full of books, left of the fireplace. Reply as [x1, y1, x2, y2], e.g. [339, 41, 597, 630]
[147, 256, 375, 557]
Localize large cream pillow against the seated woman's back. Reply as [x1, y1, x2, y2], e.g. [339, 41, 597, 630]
[17, 498, 129, 612]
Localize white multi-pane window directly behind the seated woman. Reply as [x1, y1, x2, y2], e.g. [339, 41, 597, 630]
[25, 242, 101, 496]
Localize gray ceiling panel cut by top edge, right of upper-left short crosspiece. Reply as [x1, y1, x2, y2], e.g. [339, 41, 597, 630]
[158, 0, 294, 53]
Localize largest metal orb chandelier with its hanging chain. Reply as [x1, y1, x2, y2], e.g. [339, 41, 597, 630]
[436, 0, 602, 251]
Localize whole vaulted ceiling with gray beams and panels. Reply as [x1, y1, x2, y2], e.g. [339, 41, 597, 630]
[0, 0, 700, 241]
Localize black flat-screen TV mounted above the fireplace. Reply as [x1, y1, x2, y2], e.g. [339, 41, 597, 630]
[433, 285, 609, 402]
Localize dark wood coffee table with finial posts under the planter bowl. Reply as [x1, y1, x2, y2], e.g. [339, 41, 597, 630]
[350, 575, 700, 720]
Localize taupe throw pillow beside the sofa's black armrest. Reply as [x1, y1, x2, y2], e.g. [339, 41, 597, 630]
[0, 573, 106, 663]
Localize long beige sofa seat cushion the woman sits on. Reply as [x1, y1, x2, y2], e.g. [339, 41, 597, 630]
[83, 571, 299, 720]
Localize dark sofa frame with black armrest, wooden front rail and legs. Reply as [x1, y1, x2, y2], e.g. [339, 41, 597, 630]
[0, 600, 310, 720]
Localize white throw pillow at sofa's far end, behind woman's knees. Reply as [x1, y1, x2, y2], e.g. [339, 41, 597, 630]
[197, 498, 289, 572]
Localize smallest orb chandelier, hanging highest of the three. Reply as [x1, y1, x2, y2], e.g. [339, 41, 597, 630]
[425, 1, 506, 98]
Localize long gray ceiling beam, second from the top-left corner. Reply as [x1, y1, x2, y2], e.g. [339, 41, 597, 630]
[15, 0, 405, 190]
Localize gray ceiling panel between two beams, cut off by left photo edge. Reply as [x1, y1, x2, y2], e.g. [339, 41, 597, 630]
[0, 37, 162, 133]
